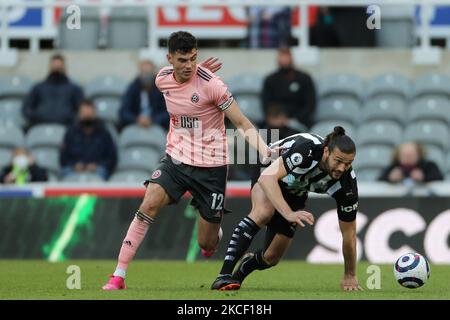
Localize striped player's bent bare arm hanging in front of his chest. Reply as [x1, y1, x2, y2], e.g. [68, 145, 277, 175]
[258, 157, 314, 227]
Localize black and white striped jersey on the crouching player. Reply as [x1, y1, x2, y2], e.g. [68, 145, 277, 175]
[270, 133, 358, 221]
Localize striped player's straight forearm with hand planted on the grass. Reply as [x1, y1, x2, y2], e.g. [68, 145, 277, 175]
[339, 220, 362, 291]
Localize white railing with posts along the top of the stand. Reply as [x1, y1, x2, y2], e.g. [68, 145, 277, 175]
[0, 0, 450, 65]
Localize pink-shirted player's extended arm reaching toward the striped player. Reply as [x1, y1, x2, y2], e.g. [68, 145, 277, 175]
[224, 101, 272, 157]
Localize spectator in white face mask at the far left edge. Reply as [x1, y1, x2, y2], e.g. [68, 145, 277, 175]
[0, 148, 48, 185]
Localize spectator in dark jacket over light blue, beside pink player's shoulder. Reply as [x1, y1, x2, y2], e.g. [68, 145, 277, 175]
[119, 60, 169, 130]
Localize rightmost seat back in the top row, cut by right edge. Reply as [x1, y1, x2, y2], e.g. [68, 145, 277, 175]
[413, 73, 450, 97]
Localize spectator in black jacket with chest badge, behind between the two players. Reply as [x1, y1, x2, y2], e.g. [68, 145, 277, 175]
[261, 48, 316, 128]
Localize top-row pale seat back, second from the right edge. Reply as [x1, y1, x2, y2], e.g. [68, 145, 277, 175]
[366, 73, 411, 99]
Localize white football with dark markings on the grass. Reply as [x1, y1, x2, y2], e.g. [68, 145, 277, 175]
[394, 253, 430, 289]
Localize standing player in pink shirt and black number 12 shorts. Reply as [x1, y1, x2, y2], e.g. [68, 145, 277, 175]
[103, 31, 273, 290]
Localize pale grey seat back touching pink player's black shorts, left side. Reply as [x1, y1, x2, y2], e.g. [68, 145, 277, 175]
[118, 147, 162, 174]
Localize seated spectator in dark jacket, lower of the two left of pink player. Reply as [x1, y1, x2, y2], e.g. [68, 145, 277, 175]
[60, 100, 117, 180]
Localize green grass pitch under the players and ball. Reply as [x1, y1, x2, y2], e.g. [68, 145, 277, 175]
[0, 260, 450, 300]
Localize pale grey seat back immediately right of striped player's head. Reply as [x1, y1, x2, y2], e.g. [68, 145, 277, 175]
[355, 120, 403, 147]
